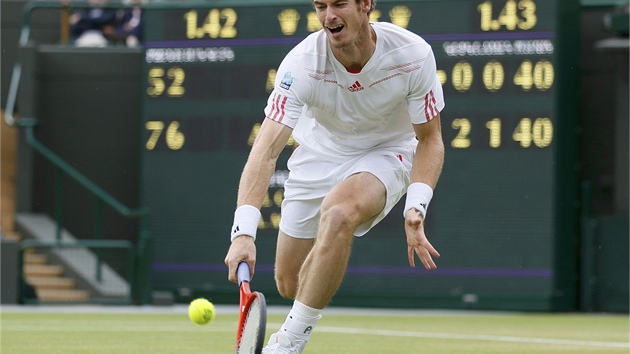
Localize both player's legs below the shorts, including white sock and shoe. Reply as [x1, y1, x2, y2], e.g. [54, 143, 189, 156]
[263, 173, 386, 353]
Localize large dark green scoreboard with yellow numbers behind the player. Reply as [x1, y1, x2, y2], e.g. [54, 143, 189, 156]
[141, 0, 578, 310]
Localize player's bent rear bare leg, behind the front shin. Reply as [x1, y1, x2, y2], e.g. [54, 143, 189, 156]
[275, 231, 315, 299]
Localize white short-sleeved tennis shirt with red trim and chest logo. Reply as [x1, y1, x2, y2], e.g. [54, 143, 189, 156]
[265, 22, 444, 161]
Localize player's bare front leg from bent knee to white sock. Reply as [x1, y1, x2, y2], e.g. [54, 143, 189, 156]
[296, 173, 386, 309]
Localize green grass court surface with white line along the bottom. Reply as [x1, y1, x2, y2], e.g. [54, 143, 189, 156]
[0, 305, 630, 354]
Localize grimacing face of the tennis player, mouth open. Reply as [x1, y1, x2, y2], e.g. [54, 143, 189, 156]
[313, 0, 371, 48]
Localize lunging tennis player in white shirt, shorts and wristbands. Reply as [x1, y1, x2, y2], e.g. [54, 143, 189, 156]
[225, 0, 444, 353]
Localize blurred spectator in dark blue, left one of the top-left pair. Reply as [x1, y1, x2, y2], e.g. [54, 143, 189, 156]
[70, 0, 116, 47]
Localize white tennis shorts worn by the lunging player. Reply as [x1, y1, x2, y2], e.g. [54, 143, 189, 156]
[280, 138, 417, 239]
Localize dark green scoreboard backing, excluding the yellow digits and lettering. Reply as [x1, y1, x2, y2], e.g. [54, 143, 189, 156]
[141, 0, 563, 310]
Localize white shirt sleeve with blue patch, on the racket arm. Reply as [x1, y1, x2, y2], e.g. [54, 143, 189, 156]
[265, 57, 308, 128]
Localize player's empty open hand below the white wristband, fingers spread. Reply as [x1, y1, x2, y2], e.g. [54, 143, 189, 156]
[405, 208, 440, 270]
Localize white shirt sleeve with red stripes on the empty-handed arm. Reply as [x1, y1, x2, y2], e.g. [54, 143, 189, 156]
[407, 49, 444, 124]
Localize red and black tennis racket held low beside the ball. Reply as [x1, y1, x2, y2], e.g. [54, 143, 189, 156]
[236, 262, 267, 354]
